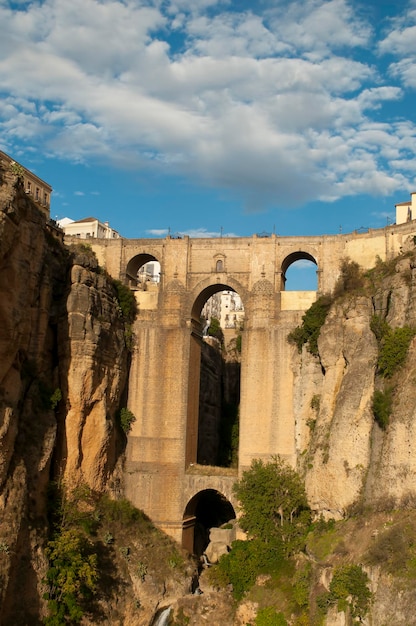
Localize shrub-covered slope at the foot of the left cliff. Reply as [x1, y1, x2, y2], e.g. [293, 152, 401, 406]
[44, 483, 187, 626]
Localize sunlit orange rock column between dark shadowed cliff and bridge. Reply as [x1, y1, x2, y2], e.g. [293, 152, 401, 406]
[59, 254, 128, 491]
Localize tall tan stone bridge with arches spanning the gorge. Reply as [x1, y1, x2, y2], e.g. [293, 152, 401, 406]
[90, 222, 416, 551]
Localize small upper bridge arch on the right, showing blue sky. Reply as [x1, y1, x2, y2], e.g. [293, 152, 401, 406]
[281, 250, 318, 291]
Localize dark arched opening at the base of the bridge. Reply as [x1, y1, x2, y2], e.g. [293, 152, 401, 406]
[182, 489, 236, 557]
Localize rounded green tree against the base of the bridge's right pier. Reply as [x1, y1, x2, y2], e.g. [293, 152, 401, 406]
[234, 457, 310, 556]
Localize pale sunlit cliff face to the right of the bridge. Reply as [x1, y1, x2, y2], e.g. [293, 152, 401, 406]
[293, 242, 416, 518]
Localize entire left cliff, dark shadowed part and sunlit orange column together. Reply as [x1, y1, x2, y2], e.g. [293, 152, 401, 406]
[0, 164, 127, 624]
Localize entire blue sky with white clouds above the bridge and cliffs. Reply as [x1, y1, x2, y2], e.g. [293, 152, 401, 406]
[0, 0, 416, 237]
